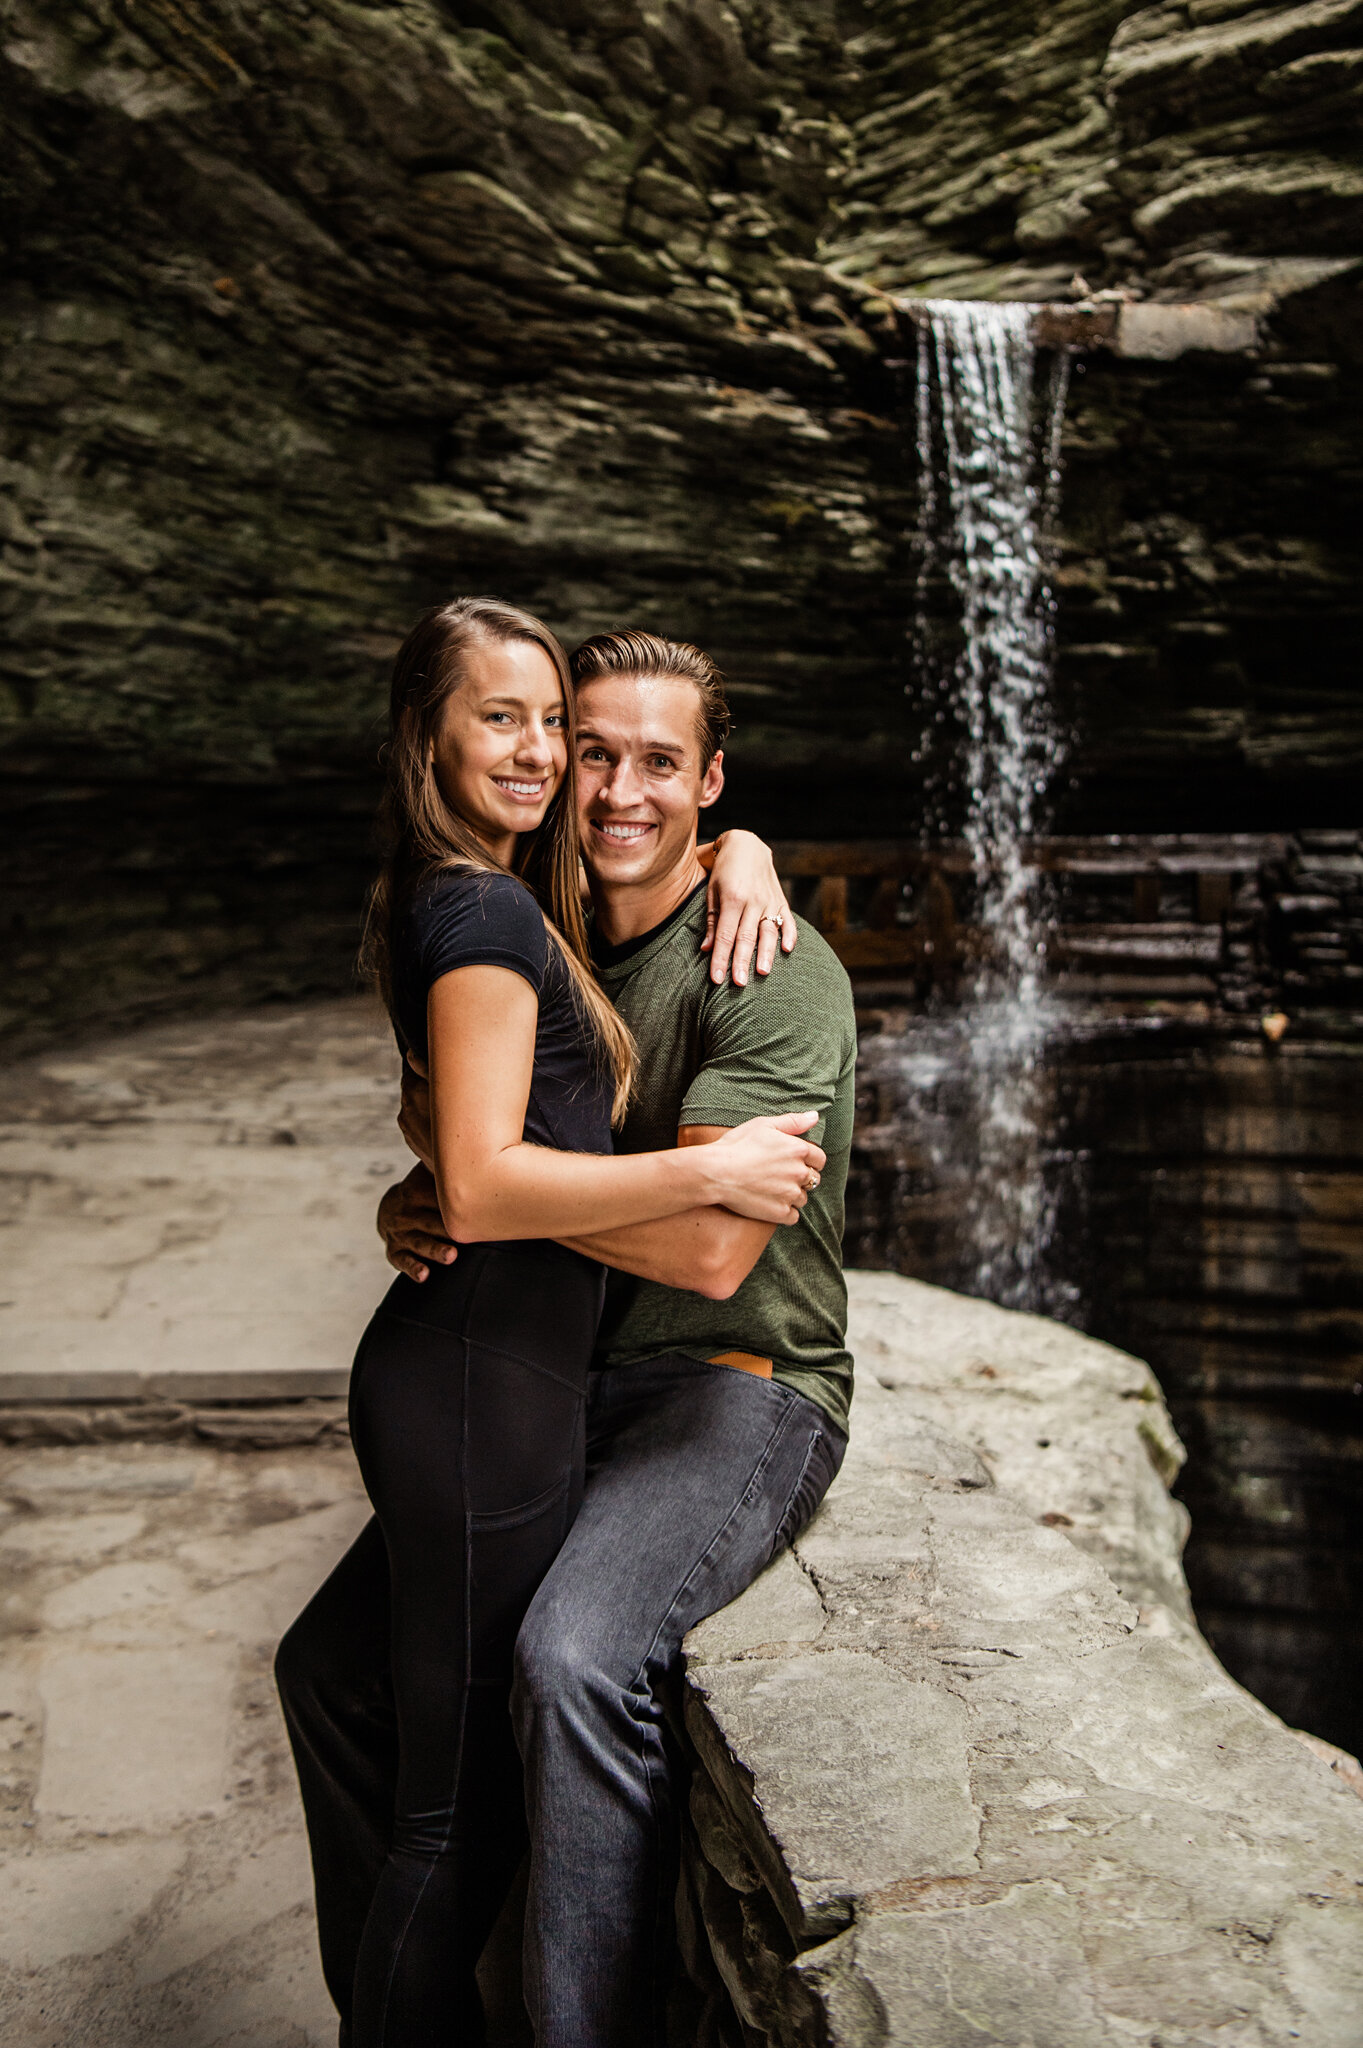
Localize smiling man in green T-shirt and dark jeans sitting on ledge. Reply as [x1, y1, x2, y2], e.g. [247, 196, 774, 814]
[278, 633, 855, 2048]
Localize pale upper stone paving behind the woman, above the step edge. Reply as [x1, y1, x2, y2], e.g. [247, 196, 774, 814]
[0, 997, 411, 1403]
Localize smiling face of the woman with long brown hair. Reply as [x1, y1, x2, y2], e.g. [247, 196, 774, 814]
[432, 641, 567, 860]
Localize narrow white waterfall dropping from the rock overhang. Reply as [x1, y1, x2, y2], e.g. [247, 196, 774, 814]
[905, 299, 1068, 1313]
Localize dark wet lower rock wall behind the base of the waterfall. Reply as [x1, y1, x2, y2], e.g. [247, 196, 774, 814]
[845, 829, 1363, 1749]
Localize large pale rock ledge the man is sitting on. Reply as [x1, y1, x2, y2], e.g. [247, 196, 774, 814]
[686, 1274, 1363, 2048]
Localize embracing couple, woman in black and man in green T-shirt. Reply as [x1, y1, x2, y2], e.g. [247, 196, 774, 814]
[278, 598, 855, 2048]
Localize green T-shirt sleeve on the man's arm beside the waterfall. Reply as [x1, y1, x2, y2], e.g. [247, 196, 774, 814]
[679, 928, 855, 1143]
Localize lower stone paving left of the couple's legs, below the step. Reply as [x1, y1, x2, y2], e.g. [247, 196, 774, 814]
[0, 1444, 368, 2048]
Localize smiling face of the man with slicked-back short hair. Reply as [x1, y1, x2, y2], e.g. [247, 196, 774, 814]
[577, 676, 724, 887]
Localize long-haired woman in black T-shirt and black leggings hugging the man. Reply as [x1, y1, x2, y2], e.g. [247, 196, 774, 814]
[331, 598, 823, 2048]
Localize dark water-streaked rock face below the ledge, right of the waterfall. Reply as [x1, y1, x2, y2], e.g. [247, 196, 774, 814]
[1062, 1032, 1363, 1747]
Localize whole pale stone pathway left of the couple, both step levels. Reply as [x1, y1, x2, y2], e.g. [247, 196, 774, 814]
[0, 1001, 405, 2048]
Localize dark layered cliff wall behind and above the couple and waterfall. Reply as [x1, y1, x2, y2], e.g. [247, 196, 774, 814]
[0, 0, 1363, 1030]
